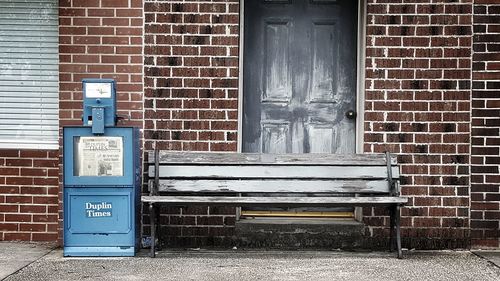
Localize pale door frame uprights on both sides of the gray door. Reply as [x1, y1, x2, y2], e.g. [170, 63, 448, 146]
[237, 0, 367, 153]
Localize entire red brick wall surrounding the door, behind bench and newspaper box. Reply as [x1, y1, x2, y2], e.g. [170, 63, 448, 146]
[0, 0, 500, 248]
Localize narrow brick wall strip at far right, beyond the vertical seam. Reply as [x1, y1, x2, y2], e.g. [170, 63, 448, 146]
[471, 0, 500, 247]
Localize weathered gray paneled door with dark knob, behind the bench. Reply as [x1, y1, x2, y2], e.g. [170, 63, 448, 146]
[243, 0, 357, 154]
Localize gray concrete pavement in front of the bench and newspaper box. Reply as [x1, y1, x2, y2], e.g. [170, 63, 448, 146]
[0, 242, 500, 281]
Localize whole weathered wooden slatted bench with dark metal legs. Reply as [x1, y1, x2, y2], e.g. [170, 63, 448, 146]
[141, 150, 407, 258]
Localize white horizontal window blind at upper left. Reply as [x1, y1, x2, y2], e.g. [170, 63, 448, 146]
[0, 0, 59, 149]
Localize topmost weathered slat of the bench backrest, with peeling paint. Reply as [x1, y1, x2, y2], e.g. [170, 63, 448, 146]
[148, 151, 397, 166]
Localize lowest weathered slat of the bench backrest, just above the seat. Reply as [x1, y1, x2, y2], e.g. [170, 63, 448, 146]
[150, 179, 389, 193]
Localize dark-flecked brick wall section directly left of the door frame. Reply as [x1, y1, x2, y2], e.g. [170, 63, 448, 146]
[144, 0, 239, 246]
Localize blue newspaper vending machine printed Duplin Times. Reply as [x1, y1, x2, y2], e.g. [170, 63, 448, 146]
[63, 79, 140, 256]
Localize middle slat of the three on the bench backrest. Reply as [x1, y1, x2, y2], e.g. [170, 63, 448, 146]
[149, 164, 399, 179]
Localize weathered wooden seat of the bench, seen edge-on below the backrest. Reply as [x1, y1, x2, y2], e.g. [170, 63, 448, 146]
[142, 196, 408, 207]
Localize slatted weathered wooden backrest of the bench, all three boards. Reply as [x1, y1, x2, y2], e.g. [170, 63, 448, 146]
[148, 151, 399, 195]
